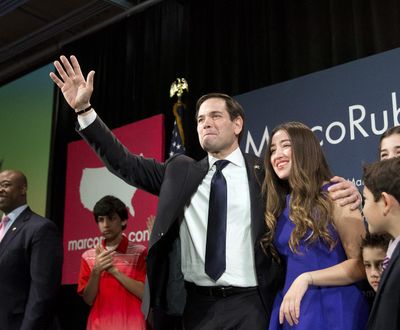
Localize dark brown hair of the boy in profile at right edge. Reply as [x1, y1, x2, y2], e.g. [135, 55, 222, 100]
[363, 157, 400, 202]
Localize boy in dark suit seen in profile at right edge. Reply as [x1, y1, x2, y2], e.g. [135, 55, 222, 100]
[363, 157, 400, 330]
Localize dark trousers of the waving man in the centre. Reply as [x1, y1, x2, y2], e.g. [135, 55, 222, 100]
[183, 288, 268, 330]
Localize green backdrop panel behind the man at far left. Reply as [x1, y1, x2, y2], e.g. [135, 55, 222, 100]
[0, 65, 54, 220]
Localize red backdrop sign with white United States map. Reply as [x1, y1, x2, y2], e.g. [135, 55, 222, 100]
[62, 115, 164, 284]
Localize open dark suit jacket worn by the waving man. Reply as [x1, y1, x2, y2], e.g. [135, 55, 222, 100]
[80, 117, 282, 315]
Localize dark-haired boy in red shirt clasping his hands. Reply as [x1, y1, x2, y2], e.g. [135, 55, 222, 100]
[78, 196, 147, 330]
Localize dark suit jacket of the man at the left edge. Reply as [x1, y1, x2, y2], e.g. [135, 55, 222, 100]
[0, 207, 62, 330]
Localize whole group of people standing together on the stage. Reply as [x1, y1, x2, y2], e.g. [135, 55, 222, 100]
[0, 56, 400, 330]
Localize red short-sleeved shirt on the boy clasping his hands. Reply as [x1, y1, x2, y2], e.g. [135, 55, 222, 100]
[78, 235, 147, 330]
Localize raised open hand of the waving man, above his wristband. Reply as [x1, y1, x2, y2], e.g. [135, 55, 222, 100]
[50, 55, 94, 112]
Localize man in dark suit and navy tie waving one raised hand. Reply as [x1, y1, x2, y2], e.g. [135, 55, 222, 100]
[50, 56, 360, 330]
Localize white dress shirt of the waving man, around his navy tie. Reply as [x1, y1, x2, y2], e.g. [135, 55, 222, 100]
[180, 148, 257, 287]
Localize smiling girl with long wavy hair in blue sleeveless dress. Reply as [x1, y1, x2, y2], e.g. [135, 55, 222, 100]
[263, 122, 369, 330]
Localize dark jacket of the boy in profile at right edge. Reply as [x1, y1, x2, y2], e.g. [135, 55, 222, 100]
[367, 244, 400, 330]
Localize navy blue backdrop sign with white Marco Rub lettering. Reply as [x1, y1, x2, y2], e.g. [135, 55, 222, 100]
[235, 49, 400, 186]
